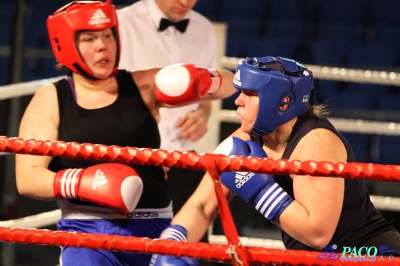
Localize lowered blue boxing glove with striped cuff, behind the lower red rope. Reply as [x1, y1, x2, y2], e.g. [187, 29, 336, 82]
[150, 224, 198, 266]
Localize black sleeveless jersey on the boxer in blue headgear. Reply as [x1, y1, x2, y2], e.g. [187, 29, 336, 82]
[274, 117, 375, 250]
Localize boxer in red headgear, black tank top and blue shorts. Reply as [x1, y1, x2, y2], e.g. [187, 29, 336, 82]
[16, 0, 235, 266]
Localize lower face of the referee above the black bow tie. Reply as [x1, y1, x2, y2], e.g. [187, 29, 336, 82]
[156, 0, 197, 21]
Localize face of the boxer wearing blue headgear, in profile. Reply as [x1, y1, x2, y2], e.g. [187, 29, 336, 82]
[235, 90, 260, 134]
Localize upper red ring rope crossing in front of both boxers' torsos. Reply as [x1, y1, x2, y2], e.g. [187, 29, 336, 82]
[0, 136, 400, 181]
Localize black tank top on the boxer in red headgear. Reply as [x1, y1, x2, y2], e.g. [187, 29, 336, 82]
[49, 70, 171, 208]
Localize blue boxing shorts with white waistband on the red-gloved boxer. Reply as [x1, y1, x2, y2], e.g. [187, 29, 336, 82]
[57, 201, 172, 266]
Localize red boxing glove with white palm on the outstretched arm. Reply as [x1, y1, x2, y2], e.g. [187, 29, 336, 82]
[155, 64, 222, 106]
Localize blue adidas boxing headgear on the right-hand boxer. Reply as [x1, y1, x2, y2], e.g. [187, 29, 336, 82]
[233, 56, 314, 136]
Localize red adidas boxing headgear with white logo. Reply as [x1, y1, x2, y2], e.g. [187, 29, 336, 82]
[47, 0, 120, 79]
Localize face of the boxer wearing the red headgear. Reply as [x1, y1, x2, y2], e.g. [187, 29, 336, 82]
[77, 29, 117, 79]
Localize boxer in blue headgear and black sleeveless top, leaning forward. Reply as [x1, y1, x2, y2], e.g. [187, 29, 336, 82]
[156, 56, 400, 258]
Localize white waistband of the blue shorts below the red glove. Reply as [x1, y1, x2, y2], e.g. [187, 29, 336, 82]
[61, 200, 173, 219]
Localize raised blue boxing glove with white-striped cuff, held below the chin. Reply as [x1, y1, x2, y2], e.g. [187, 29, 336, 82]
[214, 137, 293, 222]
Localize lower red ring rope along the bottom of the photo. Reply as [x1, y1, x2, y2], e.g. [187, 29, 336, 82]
[0, 227, 400, 266]
